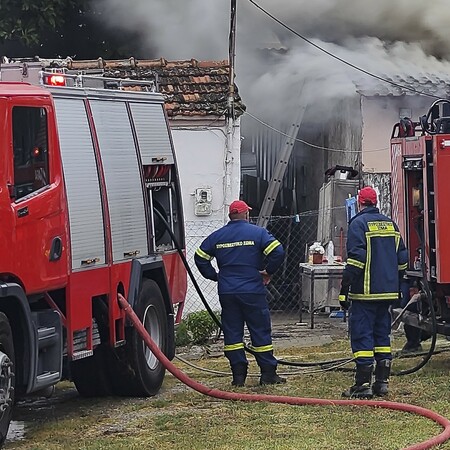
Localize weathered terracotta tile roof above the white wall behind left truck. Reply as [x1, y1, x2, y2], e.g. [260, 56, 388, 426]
[41, 58, 245, 119]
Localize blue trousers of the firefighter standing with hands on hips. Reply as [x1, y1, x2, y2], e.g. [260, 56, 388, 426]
[219, 294, 277, 367]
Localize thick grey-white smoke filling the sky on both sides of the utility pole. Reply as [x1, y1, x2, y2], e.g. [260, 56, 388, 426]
[96, 0, 450, 117]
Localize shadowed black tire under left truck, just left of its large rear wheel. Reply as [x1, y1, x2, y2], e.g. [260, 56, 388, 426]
[70, 344, 112, 397]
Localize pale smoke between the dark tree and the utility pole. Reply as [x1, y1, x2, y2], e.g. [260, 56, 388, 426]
[94, 0, 230, 60]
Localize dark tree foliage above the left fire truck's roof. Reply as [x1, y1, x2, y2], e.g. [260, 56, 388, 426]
[0, 0, 146, 59]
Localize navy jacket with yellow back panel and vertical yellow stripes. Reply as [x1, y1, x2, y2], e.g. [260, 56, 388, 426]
[342, 206, 408, 301]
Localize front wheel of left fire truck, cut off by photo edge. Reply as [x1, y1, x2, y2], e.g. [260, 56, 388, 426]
[0, 313, 15, 447]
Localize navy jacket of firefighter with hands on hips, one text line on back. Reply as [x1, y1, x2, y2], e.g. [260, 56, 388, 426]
[195, 220, 284, 295]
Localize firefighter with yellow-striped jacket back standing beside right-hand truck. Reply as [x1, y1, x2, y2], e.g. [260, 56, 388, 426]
[339, 187, 408, 398]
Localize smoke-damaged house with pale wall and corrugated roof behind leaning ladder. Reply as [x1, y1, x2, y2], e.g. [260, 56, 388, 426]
[241, 75, 450, 312]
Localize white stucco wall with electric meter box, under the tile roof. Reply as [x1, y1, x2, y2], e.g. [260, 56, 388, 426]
[171, 120, 241, 316]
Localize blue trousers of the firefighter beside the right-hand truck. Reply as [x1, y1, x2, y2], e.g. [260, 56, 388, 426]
[349, 300, 392, 364]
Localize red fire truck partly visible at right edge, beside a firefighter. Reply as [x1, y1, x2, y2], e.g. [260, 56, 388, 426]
[391, 100, 450, 336]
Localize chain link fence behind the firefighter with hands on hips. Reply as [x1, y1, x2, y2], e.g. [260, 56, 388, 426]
[183, 211, 326, 320]
